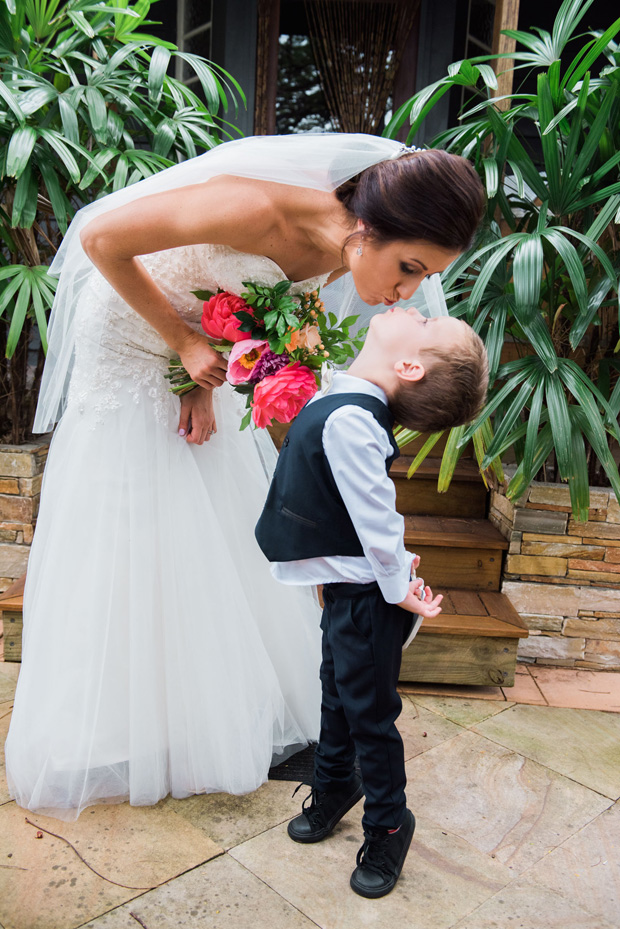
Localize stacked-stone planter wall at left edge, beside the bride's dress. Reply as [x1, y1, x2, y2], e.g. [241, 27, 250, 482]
[0, 437, 50, 592]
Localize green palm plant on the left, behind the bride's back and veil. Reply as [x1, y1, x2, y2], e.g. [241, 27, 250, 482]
[0, 0, 243, 443]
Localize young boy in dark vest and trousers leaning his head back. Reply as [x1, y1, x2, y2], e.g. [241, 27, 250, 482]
[256, 307, 488, 897]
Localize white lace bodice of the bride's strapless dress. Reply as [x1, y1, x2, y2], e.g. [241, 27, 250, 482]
[68, 245, 328, 425]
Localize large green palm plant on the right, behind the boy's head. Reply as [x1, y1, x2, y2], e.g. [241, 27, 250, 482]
[386, 0, 620, 521]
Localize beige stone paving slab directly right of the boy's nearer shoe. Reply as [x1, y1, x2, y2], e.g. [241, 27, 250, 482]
[407, 731, 610, 874]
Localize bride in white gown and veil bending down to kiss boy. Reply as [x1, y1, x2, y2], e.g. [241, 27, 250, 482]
[6, 134, 482, 819]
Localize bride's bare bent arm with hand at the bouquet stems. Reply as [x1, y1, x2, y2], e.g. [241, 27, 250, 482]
[80, 178, 273, 388]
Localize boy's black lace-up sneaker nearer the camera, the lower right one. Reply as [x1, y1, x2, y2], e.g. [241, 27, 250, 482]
[351, 810, 415, 897]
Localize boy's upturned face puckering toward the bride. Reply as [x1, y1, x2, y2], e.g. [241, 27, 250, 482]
[368, 306, 468, 360]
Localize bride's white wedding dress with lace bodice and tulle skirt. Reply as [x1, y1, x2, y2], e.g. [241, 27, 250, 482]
[6, 245, 324, 819]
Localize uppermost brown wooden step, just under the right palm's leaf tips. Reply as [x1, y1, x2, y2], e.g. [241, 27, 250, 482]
[390, 455, 487, 519]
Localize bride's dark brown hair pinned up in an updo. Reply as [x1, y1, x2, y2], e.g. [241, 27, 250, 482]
[335, 148, 485, 252]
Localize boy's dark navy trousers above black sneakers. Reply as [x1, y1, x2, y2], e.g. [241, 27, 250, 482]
[314, 583, 411, 829]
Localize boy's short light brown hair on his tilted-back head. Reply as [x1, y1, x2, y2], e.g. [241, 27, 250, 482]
[388, 326, 489, 432]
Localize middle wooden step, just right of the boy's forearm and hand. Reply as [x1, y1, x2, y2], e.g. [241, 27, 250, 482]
[405, 516, 508, 593]
